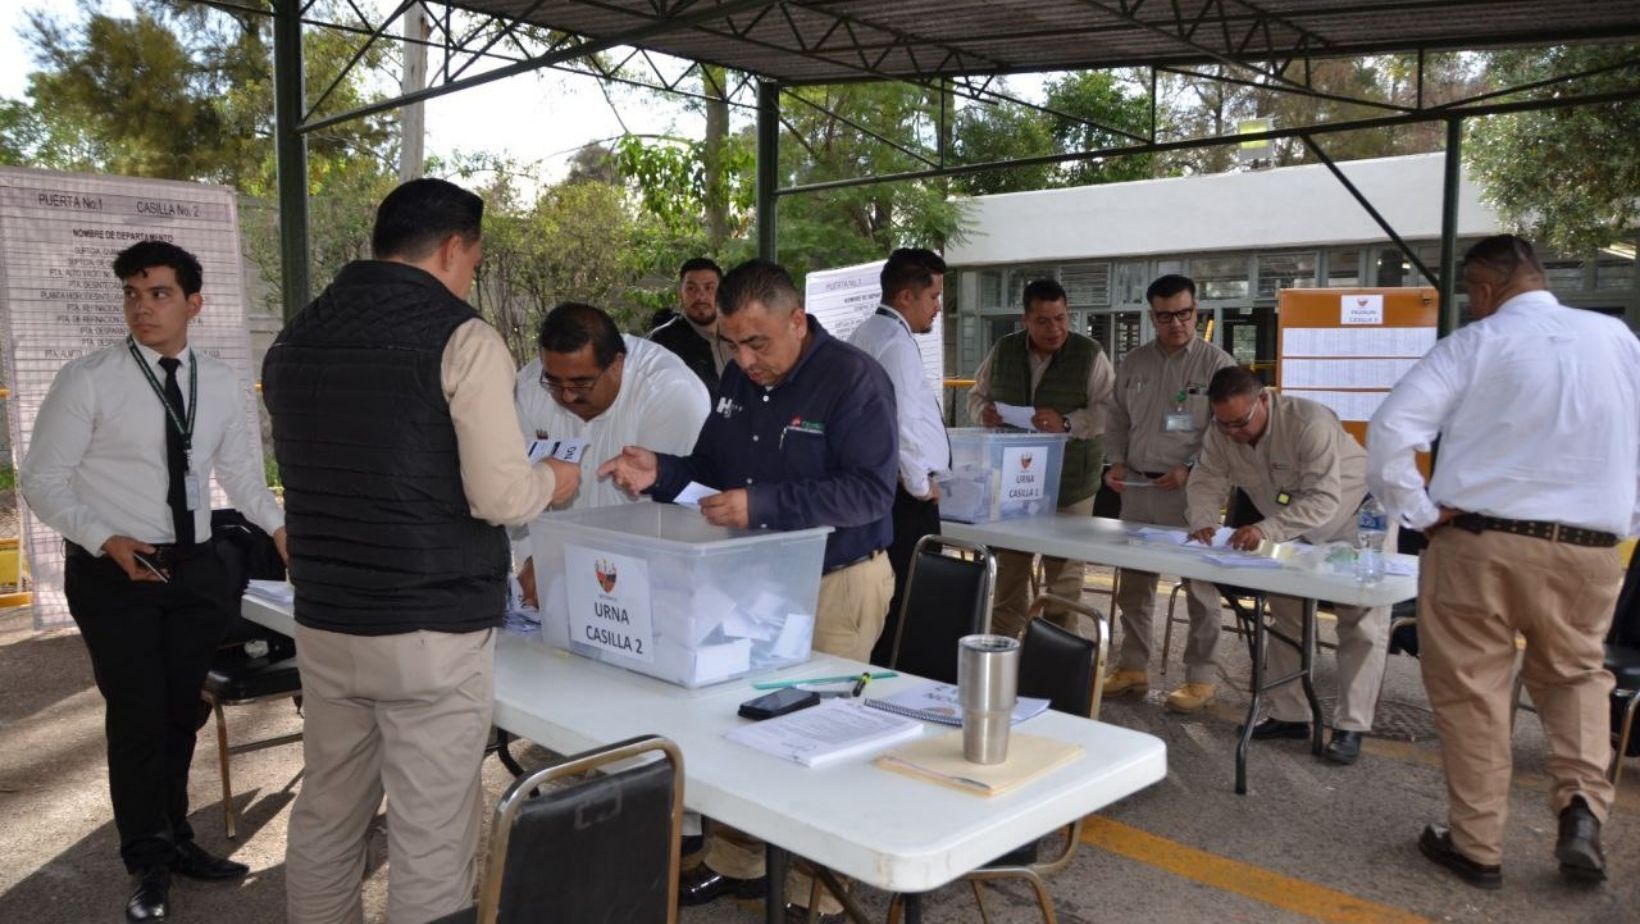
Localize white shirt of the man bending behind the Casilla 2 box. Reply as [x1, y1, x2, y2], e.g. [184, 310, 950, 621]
[513, 333, 712, 510]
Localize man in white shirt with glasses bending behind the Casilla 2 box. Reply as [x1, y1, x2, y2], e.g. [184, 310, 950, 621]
[513, 302, 712, 602]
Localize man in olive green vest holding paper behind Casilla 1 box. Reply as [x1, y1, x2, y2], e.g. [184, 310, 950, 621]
[968, 279, 1117, 635]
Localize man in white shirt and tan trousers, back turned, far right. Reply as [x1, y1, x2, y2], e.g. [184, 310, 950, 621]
[1366, 235, 1640, 888]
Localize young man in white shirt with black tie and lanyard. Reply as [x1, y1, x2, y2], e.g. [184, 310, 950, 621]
[20, 241, 285, 921]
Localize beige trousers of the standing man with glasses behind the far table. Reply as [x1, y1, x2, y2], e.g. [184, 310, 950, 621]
[1115, 487, 1220, 683]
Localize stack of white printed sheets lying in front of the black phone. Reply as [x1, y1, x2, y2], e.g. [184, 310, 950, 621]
[725, 699, 923, 766]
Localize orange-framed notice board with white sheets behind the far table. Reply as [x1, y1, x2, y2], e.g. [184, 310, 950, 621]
[1276, 286, 1440, 476]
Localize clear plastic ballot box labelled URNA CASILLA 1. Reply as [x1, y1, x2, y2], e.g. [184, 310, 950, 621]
[940, 427, 1066, 524]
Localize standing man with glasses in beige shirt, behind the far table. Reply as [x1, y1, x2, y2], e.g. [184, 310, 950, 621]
[1105, 276, 1235, 712]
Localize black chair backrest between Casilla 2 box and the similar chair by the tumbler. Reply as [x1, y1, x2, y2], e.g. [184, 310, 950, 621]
[889, 535, 997, 683]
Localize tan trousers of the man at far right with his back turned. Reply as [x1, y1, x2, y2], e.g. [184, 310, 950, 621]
[1419, 527, 1624, 863]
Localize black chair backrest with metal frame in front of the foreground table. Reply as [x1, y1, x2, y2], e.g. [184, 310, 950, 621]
[477, 735, 684, 924]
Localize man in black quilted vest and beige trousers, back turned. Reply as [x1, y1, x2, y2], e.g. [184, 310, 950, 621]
[262, 179, 579, 924]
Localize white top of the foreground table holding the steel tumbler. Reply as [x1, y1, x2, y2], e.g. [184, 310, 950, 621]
[244, 596, 1168, 891]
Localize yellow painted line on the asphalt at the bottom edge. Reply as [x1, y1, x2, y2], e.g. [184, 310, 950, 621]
[1082, 816, 1430, 924]
